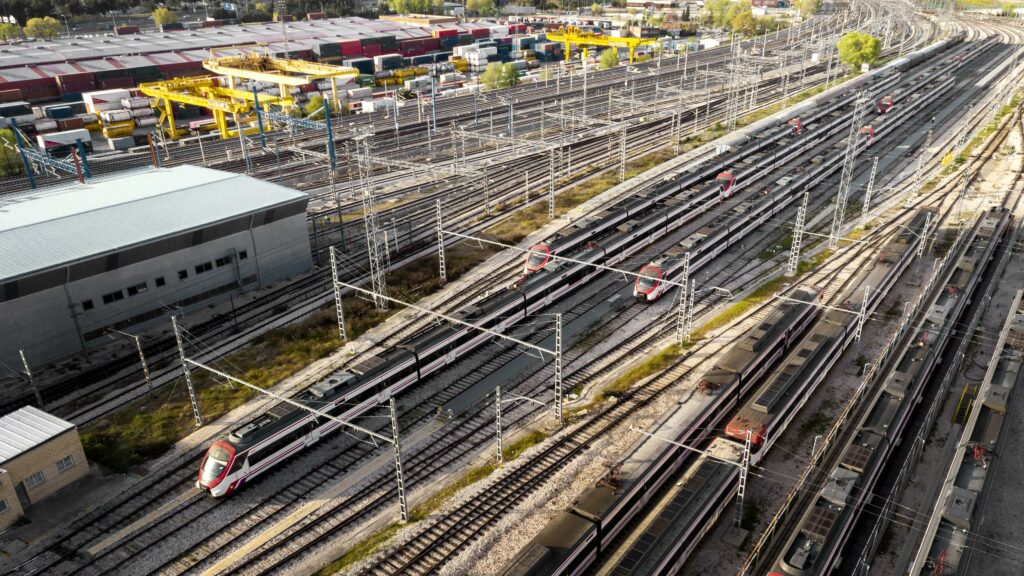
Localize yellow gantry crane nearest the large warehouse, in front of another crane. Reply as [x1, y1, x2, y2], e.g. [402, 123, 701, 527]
[138, 76, 292, 139]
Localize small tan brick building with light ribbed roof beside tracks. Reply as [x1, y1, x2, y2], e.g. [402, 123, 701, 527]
[0, 406, 89, 530]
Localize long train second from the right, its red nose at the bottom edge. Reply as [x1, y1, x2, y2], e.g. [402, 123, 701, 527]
[769, 208, 1009, 576]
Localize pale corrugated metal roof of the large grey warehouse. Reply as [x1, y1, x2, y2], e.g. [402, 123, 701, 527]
[0, 165, 306, 281]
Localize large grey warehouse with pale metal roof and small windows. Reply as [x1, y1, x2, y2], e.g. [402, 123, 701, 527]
[0, 166, 311, 366]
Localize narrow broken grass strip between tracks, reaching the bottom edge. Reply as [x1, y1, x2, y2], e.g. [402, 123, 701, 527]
[318, 430, 548, 576]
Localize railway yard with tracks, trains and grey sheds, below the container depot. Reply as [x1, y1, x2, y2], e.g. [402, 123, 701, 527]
[0, 0, 1024, 576]
